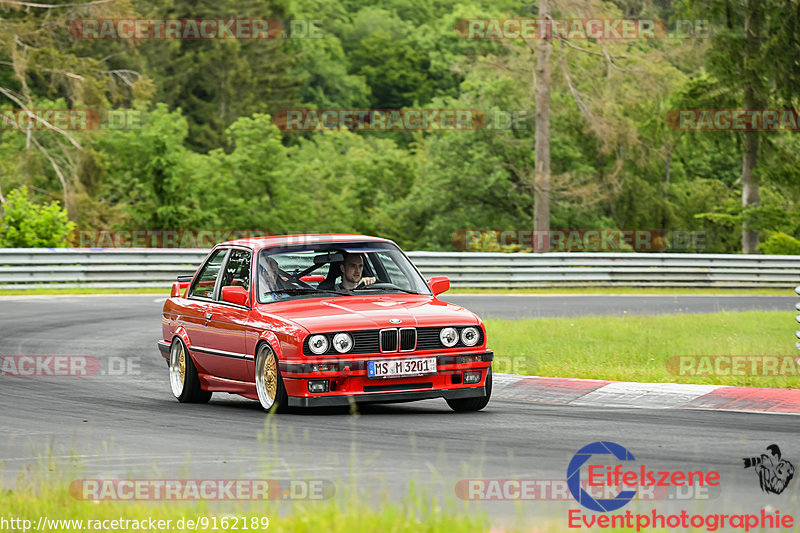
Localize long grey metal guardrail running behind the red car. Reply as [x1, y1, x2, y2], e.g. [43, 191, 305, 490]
[0, 248, 800, 289]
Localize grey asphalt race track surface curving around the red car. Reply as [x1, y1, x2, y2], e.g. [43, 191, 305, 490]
[0, 295, 800, 530]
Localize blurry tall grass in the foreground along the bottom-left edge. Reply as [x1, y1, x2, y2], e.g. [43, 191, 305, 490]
[0, 460, 489, 533]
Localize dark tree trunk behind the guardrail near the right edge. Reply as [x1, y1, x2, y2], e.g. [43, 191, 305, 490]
[742, 0, 762, 254]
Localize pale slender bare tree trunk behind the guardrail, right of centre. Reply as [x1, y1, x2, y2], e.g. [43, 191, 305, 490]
[533, 0, 552, 251]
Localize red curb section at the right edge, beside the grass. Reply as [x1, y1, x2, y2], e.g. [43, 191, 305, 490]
[681, 387, 800, 414]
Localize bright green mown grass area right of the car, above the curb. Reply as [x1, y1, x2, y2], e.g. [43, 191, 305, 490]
[485, 311, 800, 388]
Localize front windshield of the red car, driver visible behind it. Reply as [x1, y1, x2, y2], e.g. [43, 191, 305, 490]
[257, 242, 431, 303]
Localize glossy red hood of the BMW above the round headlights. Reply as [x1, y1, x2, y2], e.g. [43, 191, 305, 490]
[260, 294, 479, 333]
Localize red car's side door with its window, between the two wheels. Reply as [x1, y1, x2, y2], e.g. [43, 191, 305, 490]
[198, 248, 253, 381]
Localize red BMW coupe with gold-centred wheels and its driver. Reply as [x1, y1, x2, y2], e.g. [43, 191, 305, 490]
[158, 235, 493, 411]
